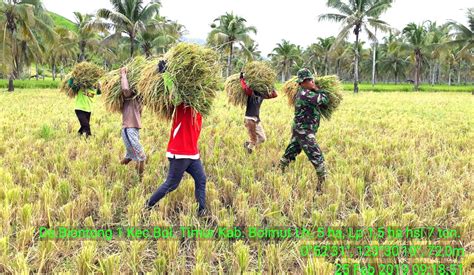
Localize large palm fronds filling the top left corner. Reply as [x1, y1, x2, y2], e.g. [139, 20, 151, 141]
[0, 0, 55, 92]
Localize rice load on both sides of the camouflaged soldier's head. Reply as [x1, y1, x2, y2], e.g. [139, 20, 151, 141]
[282, 75, 342, 120]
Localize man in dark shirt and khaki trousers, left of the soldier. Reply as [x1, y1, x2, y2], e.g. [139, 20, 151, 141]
[240, 72, 278, 154]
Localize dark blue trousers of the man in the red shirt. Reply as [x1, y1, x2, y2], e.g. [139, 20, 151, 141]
[148, 158, 206, 210]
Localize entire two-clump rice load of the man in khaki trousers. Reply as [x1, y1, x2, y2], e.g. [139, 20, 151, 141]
[224, 61, 276, 106]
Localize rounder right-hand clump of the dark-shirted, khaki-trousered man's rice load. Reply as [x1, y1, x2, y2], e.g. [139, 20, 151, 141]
[243, 61, 276, 95]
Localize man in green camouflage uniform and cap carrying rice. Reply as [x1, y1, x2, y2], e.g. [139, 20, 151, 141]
[280, 69, 329, 191]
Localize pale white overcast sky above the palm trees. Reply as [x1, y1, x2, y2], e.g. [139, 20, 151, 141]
[43, 0, 474, 55]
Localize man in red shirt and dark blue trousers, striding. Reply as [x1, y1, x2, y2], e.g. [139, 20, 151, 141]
[146, 104, 206, 216]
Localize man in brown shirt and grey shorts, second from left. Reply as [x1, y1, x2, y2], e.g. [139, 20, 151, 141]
[120, 67, 146, 180]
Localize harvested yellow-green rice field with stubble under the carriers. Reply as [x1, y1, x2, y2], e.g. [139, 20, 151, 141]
[0, 90, 474, 274]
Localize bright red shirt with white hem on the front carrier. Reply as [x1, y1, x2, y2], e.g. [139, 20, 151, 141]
[166, 104, 202, 159]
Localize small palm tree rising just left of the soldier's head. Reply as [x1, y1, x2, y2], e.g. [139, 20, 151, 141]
[268, 40, 301, 82]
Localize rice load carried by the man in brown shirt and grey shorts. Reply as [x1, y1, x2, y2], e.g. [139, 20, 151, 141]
[101, 56, 147, 113]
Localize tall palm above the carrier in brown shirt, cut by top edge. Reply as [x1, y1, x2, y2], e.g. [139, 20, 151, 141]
[93, 0, 161, 57]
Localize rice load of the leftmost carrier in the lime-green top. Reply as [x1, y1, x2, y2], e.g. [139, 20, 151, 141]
[61, 62, 105, 97]
